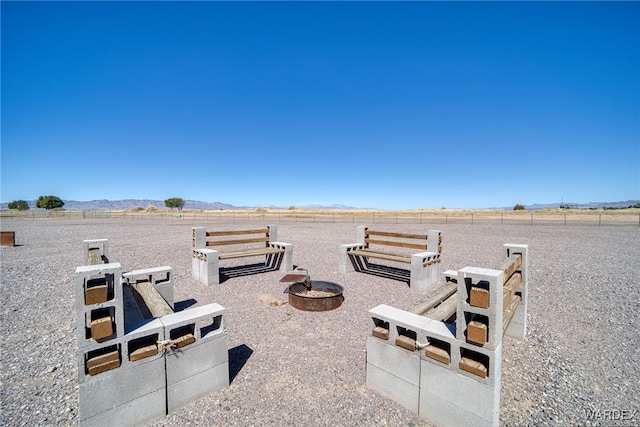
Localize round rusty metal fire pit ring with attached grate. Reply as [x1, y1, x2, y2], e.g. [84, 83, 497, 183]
[280, 272, 344, 311]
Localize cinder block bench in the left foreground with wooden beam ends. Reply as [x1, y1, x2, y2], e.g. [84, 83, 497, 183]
[76, 263, 229, 427]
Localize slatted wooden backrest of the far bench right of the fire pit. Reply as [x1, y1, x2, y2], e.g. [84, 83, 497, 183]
[358, 225, 442, 254]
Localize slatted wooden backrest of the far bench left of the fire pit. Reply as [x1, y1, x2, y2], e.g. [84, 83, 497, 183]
[191, 225, 278, 249]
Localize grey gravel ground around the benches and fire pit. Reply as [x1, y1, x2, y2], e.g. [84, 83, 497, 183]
[0, 219, 640, 426]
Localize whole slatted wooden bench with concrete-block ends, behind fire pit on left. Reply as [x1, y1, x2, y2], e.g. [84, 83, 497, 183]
[192, 225, 293, 285]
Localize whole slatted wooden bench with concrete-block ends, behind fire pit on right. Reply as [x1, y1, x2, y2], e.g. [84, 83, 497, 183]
[339, 226, 442, 289]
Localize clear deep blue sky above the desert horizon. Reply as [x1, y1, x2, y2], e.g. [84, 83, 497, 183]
[0, 1, 640, 209]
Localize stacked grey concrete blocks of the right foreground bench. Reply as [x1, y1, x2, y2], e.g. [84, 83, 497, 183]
[367, 244, 528, 426]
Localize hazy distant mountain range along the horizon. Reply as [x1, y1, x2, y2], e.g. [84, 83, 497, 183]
[0, 199, 640, 210]
